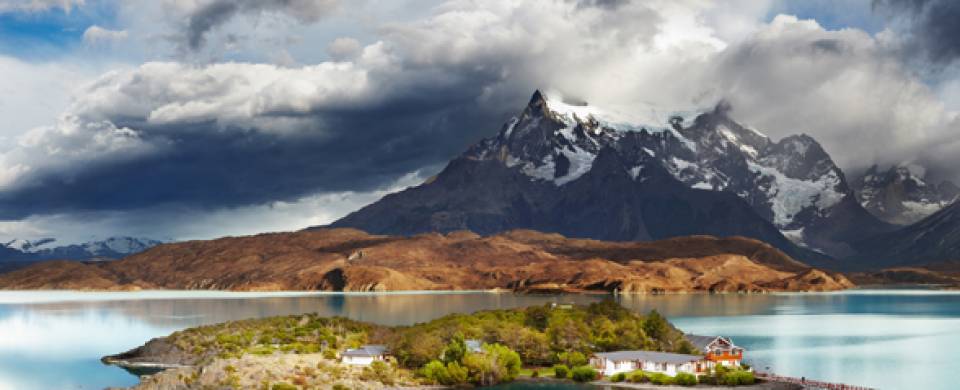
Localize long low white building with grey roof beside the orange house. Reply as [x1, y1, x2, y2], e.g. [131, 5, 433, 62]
[590, 351, 709, 376]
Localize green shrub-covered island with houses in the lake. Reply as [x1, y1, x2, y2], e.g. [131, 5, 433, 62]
[103, 300, 793, 390]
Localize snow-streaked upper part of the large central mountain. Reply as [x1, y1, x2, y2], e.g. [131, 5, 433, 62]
[467, 92, 888, 256]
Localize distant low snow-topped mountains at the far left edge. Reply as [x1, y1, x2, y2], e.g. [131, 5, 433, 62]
[0, 236, 162, 272]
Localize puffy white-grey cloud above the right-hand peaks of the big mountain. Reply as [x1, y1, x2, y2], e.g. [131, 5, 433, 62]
[703, 15, 953, 167]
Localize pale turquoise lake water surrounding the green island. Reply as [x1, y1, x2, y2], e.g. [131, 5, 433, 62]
[0, 290, 960, 390]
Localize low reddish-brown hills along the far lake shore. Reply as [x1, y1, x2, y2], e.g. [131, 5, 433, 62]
[0, 229, 852, 292]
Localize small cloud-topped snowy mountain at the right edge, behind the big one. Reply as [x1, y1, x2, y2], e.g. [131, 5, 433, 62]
[853, 164, 960, 225]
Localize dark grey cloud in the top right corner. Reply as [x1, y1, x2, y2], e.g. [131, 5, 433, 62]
[873, 0, 960, 66]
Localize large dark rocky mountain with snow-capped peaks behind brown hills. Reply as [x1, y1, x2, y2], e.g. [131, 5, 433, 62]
[333, 92, 893, 265]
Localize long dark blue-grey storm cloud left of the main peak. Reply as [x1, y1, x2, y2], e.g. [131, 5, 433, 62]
[0, 89, 516, 219]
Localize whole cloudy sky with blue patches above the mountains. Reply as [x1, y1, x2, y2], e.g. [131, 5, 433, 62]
[0, 0, 960, 243]
